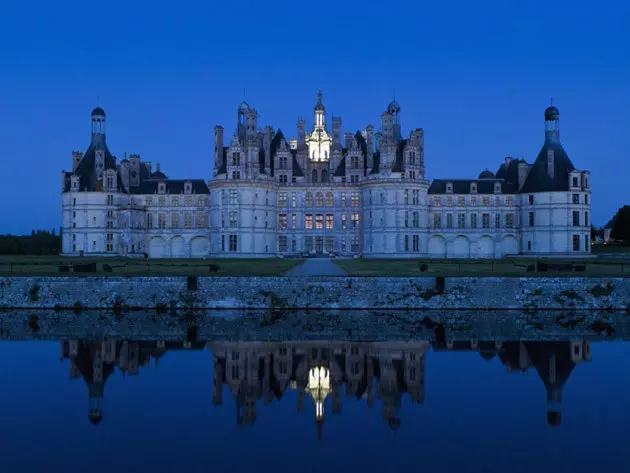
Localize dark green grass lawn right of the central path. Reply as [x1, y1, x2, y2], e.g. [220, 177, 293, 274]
[333, 258, 630, 277]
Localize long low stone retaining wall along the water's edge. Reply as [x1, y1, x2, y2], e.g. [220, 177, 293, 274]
[0, 276, 630, 311]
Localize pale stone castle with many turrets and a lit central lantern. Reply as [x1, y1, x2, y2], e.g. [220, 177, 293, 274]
[62, 92, 591, 258]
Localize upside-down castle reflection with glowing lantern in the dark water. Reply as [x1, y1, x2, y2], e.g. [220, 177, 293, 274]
[61, 337, 590, 434]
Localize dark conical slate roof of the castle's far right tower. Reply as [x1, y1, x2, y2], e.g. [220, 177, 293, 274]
[521, 138, 575, 193]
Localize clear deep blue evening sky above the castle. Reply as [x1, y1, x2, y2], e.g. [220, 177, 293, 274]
[0, 0, 630, 233]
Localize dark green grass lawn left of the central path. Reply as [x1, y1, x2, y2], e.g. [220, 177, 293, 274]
[0, 256, 304, 276]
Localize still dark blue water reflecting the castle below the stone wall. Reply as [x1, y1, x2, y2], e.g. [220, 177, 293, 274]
[0, 312, 630, 473]
